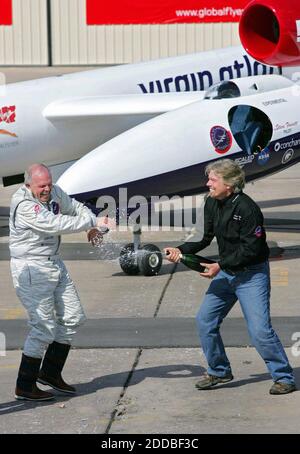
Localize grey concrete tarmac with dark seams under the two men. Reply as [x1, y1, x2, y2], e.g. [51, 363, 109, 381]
[0, 66, 300, 436]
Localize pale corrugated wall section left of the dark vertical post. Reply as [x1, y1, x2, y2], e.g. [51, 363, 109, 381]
[0, 0, 48, 65]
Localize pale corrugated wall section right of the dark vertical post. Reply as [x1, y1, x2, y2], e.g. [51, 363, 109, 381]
[51, 0, 239, 65]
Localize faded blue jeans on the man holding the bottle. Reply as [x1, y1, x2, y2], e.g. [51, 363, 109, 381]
[196, 262, 294, 383]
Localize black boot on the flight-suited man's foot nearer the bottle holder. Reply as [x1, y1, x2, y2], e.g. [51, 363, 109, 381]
[37, 341, 76, 394]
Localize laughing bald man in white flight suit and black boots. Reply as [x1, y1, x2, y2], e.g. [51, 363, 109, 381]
[9, 164, 111, 401]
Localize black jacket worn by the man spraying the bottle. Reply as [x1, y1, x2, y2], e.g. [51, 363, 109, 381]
[179, 192, 269, 272]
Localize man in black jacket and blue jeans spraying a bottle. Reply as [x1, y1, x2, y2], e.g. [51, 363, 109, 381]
[165, 159, 296, 394]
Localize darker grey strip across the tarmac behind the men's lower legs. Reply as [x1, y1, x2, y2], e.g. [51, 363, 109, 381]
[0, 317, 300, 350]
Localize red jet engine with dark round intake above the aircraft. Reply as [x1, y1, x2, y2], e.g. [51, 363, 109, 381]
[239, 0, 300, 66]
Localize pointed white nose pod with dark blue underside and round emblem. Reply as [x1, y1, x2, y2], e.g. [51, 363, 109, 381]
[58, 75, 300, 200]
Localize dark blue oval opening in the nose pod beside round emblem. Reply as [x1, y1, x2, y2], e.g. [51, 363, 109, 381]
[228, 104, 273, 155]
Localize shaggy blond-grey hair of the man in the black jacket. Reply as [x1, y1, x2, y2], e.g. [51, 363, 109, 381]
[205, 159, 245, 193]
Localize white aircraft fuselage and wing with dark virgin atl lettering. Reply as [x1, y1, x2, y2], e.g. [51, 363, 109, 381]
[0, 43, 280, 185]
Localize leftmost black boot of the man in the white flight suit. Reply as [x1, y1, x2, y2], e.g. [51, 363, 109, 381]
[15, 353, 54, 401]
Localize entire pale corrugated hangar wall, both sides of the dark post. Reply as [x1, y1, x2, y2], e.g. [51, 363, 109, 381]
[0, 0, 239, 65]
